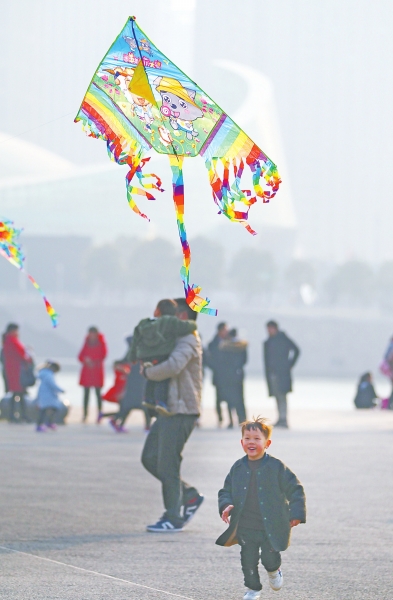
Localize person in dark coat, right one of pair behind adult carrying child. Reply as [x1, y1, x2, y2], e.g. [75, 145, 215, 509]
[216, 329, 248, 428]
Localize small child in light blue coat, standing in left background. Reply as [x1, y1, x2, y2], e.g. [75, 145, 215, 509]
[37, 361, 64, 432]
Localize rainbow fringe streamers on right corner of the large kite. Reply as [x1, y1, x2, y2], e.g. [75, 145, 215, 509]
[205, 157, 281, 235]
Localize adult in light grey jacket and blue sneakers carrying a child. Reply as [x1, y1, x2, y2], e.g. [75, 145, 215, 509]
[142, 298, 204, 533]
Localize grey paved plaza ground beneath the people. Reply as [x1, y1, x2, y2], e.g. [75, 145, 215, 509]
[0, 411, 393, 600]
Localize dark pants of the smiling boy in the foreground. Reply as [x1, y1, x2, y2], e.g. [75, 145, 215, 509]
[237, 528, 281, 591]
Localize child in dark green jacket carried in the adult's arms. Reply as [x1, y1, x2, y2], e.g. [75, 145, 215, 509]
[127, 299, 196, 416]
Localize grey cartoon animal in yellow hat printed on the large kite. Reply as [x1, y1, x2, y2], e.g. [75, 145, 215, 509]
[154, 77, 203, 140]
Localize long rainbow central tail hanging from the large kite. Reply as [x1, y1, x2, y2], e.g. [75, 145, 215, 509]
[169, 155, 217, 316]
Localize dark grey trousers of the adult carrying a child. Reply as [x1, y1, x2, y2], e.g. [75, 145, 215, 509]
[142, 414, 198, 526]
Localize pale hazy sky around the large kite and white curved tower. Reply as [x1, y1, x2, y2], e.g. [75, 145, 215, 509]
[0, 0, 393, 262]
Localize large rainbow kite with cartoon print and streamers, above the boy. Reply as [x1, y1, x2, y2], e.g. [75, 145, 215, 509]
[75, 17, 280, 315]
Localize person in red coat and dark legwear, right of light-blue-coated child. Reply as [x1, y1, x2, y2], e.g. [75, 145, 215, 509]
[78, 327, 107, 423]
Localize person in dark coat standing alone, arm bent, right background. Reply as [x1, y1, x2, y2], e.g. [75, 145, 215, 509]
[263, 321, 300, 428]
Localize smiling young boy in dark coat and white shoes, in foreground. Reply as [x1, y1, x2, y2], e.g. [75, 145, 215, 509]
[216, 417, 306, 600]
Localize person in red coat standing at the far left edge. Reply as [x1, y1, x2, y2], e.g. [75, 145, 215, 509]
[1, 323, 31, 422]
